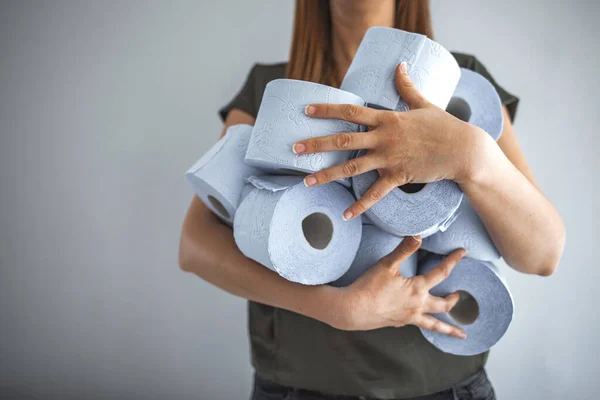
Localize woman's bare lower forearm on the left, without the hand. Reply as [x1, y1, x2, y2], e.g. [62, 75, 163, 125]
[179, 197, 344, 326]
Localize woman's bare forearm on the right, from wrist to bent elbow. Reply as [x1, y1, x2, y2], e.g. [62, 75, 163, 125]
[459, 131, 565, 276]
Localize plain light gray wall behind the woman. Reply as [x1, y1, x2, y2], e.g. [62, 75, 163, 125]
[0, 0, 600, 399]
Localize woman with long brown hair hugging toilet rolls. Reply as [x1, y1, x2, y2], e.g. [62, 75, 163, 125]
[180, 0, 565, 399]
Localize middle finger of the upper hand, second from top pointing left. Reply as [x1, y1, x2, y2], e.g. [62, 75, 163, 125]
[292, 132, 377, 154]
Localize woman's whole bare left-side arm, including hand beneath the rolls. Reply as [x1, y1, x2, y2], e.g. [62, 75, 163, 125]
[179, 110, 465, 337]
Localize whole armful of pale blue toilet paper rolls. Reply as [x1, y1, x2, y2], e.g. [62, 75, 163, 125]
[186, 27, 513, 355]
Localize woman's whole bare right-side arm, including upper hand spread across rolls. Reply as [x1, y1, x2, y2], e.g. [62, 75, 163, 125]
[294, 64, 565, 276]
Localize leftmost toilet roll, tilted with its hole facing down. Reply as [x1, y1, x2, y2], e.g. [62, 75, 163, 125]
[185, 124, 260, 225]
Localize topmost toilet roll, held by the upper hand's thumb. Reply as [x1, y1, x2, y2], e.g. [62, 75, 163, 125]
[340, 27, 460, 111]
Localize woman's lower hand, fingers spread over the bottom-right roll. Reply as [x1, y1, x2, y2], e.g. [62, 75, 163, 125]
[338, 237, 467, 339]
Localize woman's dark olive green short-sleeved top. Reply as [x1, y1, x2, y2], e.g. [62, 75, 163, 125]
[220, 53, 518, 399]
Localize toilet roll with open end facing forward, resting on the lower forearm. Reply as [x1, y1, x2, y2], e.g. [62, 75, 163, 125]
[233, 176, 362, 285]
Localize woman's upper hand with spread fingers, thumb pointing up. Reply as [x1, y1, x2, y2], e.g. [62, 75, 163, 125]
[293, 63, 495, 220]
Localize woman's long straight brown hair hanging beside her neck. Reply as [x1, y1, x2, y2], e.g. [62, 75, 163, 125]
[286, 0, 433, 86]
